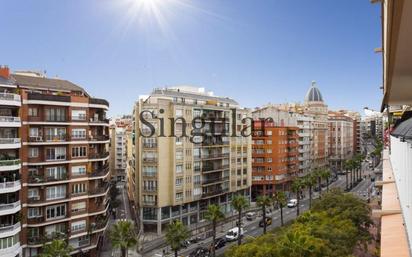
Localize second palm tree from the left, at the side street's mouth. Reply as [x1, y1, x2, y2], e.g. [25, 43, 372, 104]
[109, 220, 137, 257]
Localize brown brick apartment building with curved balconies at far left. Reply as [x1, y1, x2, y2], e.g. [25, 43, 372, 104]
[0, 68, 110, 256]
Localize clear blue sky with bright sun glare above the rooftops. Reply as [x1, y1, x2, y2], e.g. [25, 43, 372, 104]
[0, 0, 382, 116]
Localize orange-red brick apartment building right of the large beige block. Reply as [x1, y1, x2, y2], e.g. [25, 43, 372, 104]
[252, 120, 299, 199]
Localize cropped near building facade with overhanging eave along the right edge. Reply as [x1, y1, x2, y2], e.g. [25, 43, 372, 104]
[374, 0, 412, 257]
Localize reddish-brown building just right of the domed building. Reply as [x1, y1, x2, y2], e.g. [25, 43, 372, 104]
[328, 111, 356, 172]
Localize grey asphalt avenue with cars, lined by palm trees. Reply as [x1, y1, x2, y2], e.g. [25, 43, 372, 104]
[156, 163, 373, 256]
